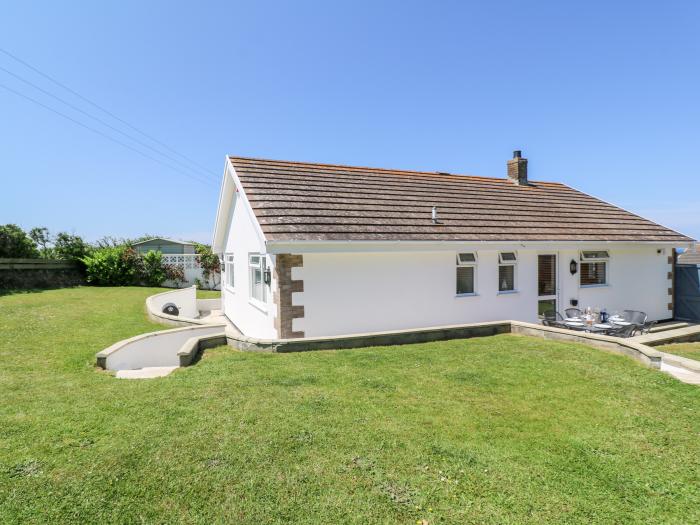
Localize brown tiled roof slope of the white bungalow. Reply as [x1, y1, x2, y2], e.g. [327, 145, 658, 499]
[229, 157, 691, 243]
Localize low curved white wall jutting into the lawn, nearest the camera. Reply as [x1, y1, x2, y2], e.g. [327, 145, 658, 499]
[97, 324, 226, 370]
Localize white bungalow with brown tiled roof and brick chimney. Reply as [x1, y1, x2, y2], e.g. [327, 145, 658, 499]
[213, 152, 694, 339]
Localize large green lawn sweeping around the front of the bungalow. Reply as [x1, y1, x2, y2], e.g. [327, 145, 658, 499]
[0, 288, 700, 525]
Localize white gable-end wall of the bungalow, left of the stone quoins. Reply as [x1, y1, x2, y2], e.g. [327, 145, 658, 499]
[221, 190, 277, 339]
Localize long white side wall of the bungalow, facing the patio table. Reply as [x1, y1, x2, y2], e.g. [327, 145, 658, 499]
[292, 245, 671, 337]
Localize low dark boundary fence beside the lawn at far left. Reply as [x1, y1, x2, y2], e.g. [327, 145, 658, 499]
[0, 259, 85, 290]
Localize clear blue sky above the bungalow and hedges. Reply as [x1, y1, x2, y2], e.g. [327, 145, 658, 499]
[0, 0, 700, 241]
